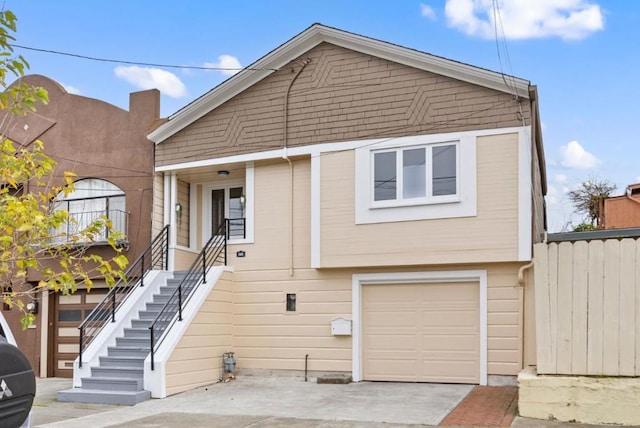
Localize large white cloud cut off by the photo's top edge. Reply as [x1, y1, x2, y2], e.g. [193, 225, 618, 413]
[445, 0, 604, 40]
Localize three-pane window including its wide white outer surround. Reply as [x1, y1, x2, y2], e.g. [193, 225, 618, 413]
[355, 133, 476, 224]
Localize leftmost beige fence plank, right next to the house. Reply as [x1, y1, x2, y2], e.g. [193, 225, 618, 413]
[533, 243, 551, 374]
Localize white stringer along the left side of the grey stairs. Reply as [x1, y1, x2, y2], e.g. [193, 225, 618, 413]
[73, 270, 173, 388]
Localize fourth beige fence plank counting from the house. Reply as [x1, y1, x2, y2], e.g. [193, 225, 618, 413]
[587, 241, 604, 375]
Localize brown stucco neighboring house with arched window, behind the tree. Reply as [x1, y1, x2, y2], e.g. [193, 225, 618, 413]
[3, 75, 160, 377]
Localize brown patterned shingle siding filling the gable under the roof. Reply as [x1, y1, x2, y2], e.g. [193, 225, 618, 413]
[156, 43, 530, 165]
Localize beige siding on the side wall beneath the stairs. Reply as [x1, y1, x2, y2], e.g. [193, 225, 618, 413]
[166, 273, 233, 395]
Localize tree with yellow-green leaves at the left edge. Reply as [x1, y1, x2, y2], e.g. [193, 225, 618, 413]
[0, 10, 128, 327]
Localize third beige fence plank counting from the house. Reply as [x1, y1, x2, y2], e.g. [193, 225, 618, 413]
[571, 241, 589, 375]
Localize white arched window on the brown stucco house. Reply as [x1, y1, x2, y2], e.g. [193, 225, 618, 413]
[55, 178, 127, 242]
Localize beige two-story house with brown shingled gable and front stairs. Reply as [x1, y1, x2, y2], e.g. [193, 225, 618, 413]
[59, 24, 546, 404]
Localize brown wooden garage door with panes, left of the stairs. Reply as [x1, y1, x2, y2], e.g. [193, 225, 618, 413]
[53, 288, 107, 377]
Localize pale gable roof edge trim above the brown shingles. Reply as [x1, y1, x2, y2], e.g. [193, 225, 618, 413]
[148, 24, 530, 144]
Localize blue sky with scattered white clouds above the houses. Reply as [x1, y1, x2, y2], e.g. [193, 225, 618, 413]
[4, 0, 640, 232]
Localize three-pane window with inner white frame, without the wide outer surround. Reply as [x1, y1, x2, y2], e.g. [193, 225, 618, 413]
[371, 142, 459, 208]
